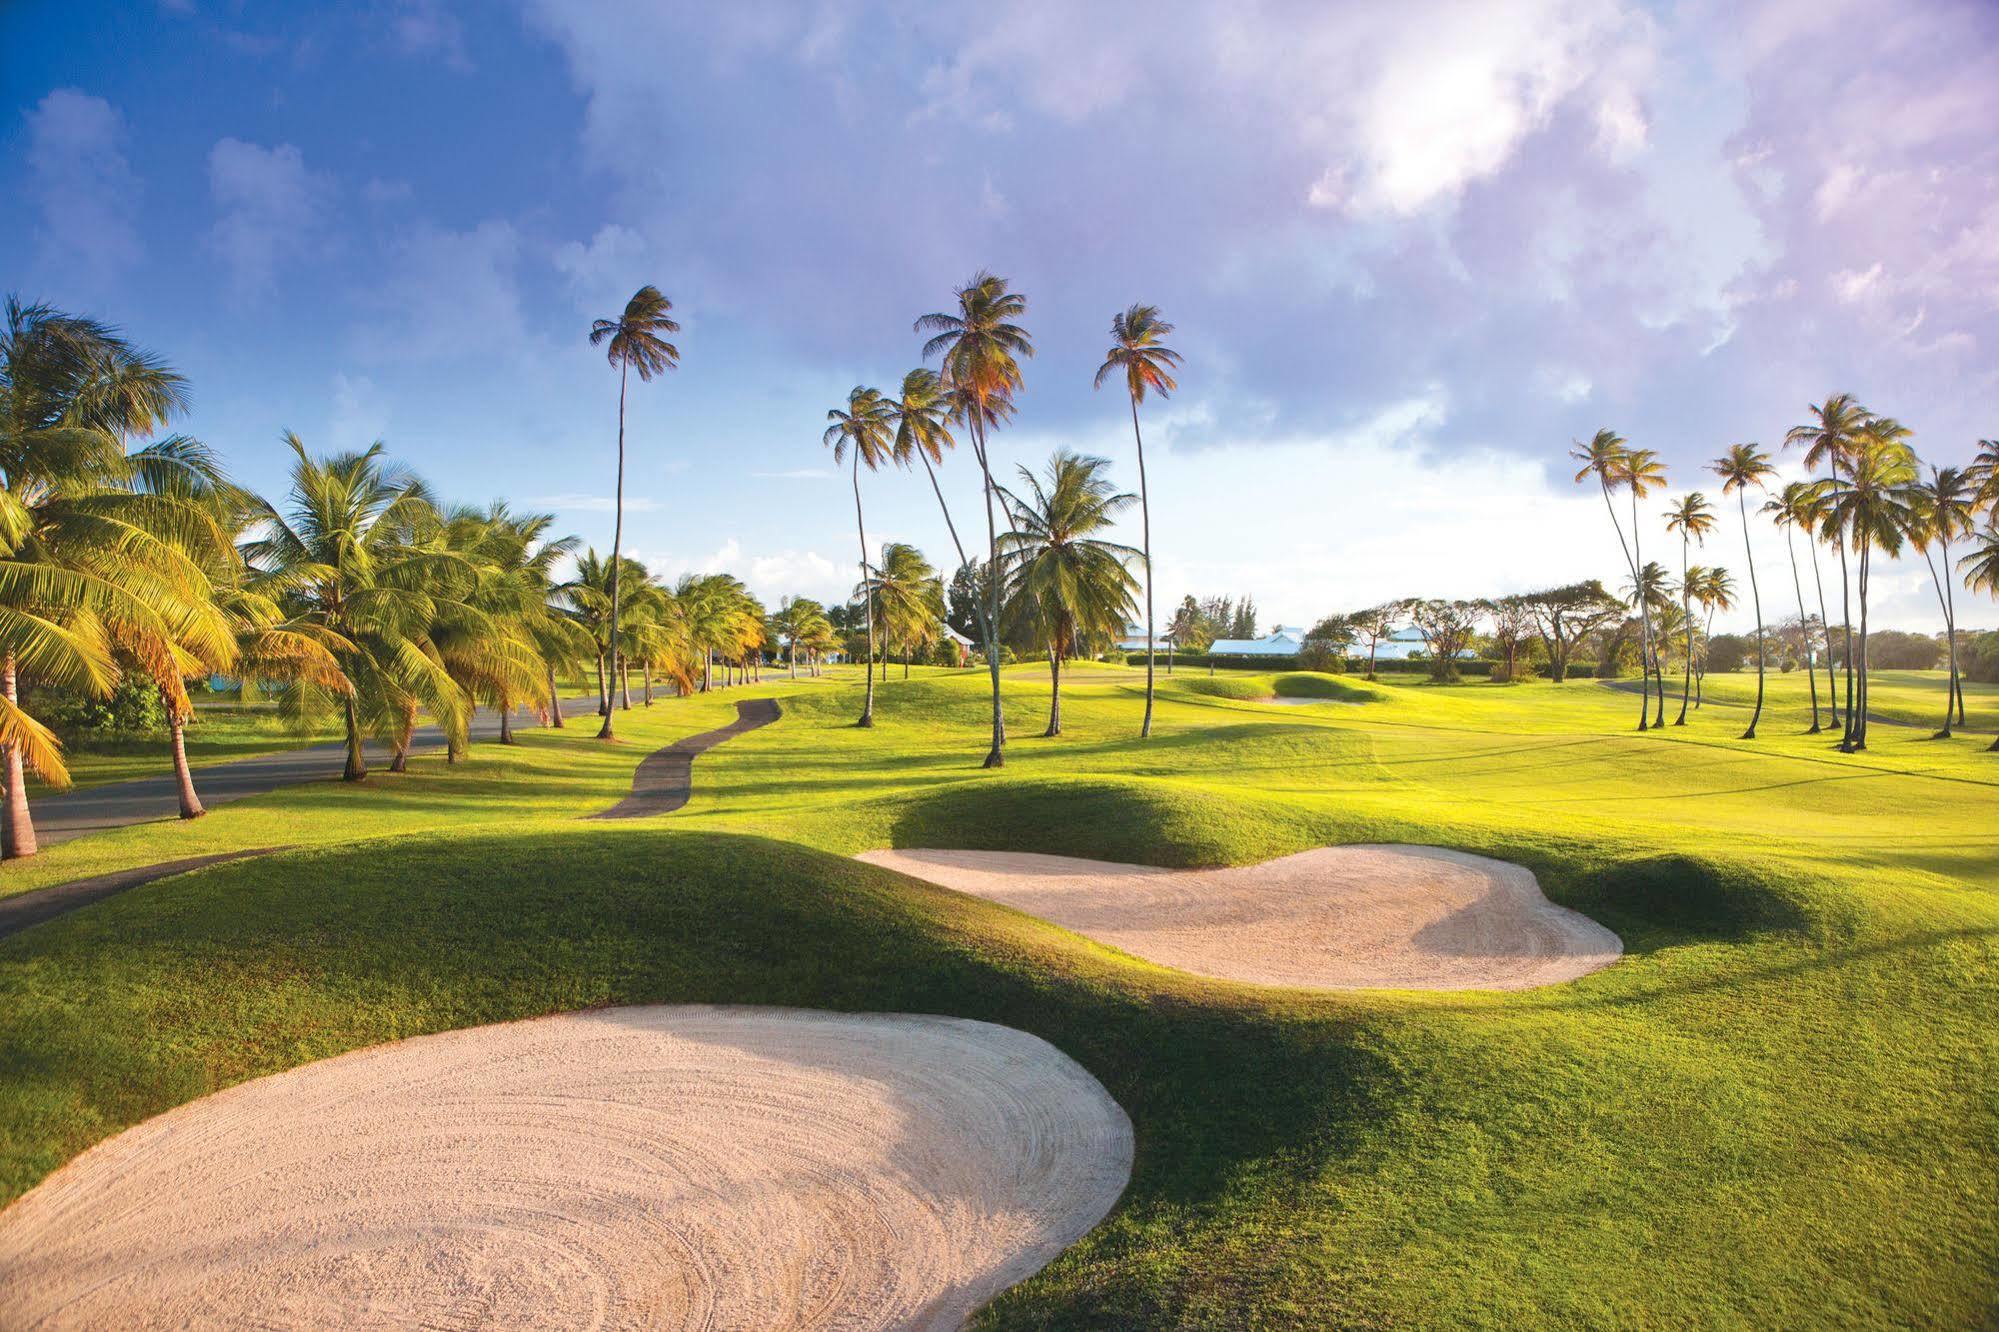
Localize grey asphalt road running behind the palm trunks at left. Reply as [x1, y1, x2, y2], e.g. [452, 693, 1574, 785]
[28, 694, 598, 846]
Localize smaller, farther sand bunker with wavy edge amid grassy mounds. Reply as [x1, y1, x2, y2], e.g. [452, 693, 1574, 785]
[862, 846, 1623, 990]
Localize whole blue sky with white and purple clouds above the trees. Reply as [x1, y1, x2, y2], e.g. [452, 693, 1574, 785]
[0, 0, 1999, 626]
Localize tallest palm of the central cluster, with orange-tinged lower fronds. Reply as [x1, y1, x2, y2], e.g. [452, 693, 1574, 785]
[916, 272, 1033, 768]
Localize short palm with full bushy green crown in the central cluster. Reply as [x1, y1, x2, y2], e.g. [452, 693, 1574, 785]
[1000, 448, 1139, 736]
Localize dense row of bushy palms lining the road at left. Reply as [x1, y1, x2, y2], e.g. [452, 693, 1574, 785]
[0, 294, 819, 858]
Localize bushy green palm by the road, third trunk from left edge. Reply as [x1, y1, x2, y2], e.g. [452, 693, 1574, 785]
[244, 432, 478, 782]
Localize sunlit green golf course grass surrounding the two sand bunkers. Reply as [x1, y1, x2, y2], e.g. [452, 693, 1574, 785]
[0, 668, 1999, 1328]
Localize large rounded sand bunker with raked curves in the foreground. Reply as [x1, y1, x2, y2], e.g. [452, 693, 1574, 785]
[0, 1006, 1131, 1328]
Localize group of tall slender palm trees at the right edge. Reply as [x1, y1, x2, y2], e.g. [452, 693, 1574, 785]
[1569, 394, 1999, 752]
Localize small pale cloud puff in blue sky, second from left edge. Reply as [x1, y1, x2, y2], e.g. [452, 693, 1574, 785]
[208, 138, 334, 298]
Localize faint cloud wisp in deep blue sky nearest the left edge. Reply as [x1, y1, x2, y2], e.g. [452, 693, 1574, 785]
[28, 88, 142, 282]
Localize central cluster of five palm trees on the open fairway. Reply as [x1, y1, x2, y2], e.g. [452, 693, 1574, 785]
[824, 272, 1179, 768]
